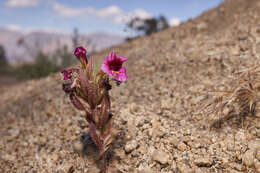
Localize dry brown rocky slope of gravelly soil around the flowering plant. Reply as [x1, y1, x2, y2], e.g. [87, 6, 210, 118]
[0, 0, 260, 173]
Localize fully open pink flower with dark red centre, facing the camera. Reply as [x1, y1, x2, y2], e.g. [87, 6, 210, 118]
[101, 52, 129, 82]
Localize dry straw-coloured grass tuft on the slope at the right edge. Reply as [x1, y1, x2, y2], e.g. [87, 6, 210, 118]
[200, 65, 260, 127]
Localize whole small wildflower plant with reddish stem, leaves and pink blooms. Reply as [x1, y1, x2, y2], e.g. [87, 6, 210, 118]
[61, 47, 129, 172]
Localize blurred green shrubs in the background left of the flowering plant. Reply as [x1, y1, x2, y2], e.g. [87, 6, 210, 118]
[0, 28, 83, 80]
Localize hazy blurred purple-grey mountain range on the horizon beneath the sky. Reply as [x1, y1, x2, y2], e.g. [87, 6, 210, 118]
[0, 28, 124, 63]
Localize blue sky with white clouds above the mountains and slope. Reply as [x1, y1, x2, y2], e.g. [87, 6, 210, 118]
[0, 0, 223, 35]
